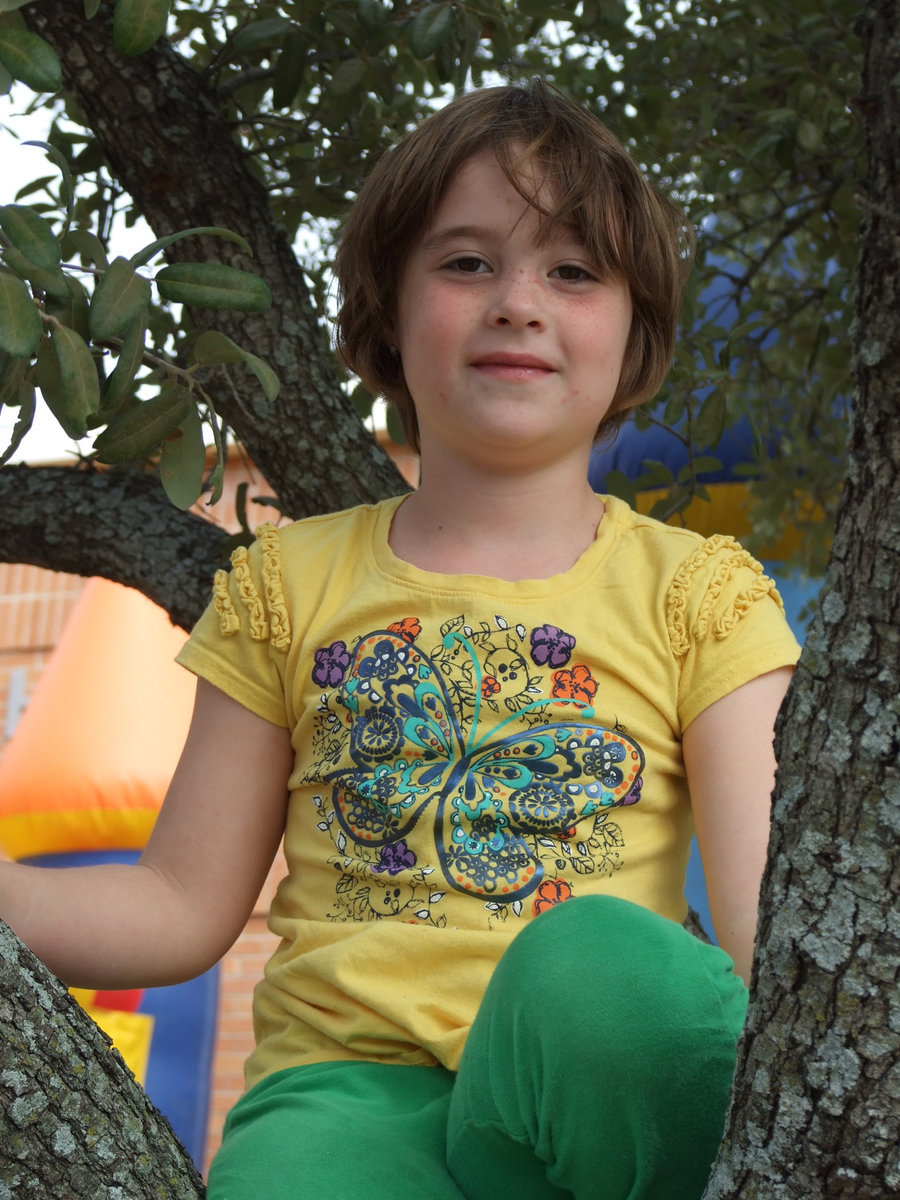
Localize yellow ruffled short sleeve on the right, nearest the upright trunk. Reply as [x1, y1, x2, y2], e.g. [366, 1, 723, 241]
[666, 535, 800, 730]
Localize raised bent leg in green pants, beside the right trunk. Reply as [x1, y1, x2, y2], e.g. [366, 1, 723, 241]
[448, 896, 746, 1200]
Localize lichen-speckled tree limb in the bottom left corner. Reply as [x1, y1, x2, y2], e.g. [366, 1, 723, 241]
[0, 923, 204, 1200]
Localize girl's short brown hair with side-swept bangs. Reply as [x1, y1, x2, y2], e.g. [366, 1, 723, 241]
[335, 79, 694, 449]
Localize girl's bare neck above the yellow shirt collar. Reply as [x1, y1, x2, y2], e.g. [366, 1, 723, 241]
[390, 451, 604, 580]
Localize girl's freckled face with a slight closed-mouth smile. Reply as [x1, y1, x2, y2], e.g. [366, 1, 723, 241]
[392, 152, 631, 470]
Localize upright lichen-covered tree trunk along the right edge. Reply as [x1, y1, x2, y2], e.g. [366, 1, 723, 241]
[706, 0, 900, 1200]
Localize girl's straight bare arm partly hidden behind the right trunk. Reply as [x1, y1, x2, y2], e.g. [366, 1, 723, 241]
[682, 667, 792, 983]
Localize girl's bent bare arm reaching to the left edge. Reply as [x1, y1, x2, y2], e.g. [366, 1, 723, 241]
[0, 680, 293, 989]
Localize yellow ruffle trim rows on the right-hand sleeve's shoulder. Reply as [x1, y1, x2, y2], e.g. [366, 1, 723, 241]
[666, 534, 785, 658]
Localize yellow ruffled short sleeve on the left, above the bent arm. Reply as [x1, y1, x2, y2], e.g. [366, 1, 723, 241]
[176, 526, 290, 727]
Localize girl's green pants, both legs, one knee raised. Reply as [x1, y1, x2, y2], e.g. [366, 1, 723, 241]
[208, 896, 746, 1200]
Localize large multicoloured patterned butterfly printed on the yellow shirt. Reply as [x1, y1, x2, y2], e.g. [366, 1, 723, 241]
[325, 630, 644, 901]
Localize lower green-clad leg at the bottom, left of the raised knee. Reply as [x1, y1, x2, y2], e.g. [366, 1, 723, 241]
[206, 1062, 464, 1200]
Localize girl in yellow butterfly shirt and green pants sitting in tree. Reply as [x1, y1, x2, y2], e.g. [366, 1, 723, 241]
[0, 82, 797, 1200]
